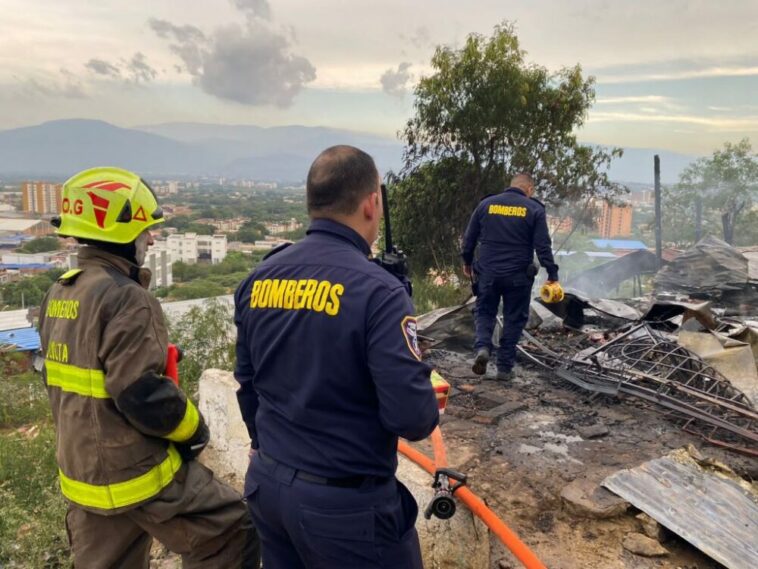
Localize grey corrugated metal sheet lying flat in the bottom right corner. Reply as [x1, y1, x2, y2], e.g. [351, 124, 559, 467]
[603, 449, 758, 569]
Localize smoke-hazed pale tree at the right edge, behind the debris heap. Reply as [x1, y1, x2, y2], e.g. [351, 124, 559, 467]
[664, 138, 758, 245]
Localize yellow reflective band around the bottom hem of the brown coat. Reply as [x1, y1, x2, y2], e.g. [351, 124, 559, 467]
[58, 445, 182, 510]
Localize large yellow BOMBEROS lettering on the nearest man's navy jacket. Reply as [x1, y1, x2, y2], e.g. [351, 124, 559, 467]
[250, 279, 345, 316]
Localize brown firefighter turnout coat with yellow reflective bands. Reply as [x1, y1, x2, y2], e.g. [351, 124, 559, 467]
[39, 247, 207, 515]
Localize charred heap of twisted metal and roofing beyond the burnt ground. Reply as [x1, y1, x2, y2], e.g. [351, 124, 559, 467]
[419, 238, 758, 457]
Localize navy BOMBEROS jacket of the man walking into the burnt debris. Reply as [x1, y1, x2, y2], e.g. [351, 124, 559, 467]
[462, 188, 558, 281]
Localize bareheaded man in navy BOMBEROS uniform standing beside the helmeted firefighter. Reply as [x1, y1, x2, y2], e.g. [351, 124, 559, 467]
[235, 146, 439, 569]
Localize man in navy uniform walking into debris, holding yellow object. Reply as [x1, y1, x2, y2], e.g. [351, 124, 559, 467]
[462, 174, 558, 380]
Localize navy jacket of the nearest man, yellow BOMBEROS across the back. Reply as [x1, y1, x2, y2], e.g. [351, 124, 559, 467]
[235, 219, 439, 478]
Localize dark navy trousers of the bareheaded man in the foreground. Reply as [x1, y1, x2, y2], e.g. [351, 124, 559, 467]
[245, 453, 423, 569]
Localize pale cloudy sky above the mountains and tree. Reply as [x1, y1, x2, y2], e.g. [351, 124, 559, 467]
[0, 0, 758, 154]
